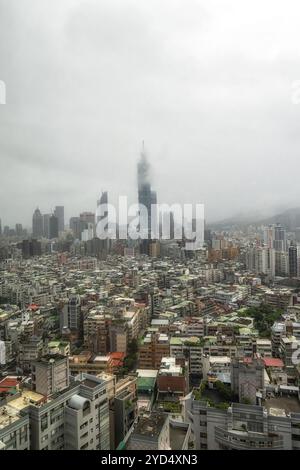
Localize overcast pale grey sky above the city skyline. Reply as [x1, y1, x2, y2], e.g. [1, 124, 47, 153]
[0, 0, 300, 225]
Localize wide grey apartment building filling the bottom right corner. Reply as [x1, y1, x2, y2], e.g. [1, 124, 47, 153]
[184, 393, 300, 450]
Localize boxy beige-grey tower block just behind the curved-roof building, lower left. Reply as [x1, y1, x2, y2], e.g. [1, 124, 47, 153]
[32, 354, 69, 397]
